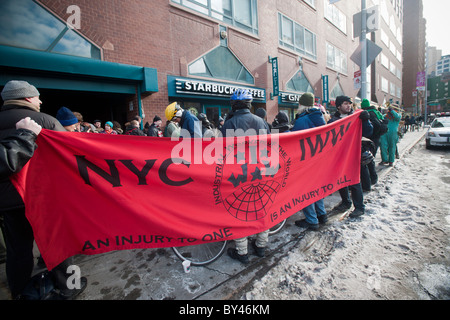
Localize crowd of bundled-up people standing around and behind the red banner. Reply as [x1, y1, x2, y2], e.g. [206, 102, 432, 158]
[0, 80, 401, 299]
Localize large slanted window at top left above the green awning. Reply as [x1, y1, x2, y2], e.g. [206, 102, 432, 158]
[0, 0, 101, 59]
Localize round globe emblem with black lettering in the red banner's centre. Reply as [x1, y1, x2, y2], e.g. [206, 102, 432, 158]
[214, 138, 290, 221]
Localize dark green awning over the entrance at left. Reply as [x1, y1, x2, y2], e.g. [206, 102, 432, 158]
[0, 45, 158, 94]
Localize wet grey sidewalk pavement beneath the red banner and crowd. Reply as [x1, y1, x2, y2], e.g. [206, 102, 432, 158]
[0, 129, 426, 300]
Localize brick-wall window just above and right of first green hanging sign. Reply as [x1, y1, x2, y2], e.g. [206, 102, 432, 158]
[278, 13, 317, 60]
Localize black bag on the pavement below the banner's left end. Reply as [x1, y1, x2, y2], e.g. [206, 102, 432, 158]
[20, 271, 58, 300]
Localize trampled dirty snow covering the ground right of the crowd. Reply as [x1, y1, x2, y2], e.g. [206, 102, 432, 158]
[243, 140, 450, 300]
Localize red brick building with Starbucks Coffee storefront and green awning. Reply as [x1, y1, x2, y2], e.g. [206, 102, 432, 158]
[0, 0, 401, 124]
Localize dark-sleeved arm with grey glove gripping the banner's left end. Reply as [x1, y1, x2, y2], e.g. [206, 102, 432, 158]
[0, 117, 42, 180]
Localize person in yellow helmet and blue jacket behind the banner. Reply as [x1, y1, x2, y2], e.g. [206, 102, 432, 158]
[165, 102, 202, 138]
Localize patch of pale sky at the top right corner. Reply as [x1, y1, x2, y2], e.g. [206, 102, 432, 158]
[424, 0, 450, 56]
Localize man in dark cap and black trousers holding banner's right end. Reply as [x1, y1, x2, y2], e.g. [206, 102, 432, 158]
[328, 96, 373, 217]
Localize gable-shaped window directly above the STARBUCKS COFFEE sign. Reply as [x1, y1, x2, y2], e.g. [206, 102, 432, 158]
[189, 46, 255, 84]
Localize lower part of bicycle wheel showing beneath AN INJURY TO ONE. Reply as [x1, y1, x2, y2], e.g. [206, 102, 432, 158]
[172, 240, 228, 266]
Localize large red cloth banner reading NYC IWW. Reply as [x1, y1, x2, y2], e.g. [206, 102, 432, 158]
[12, 113, 361, 269]
